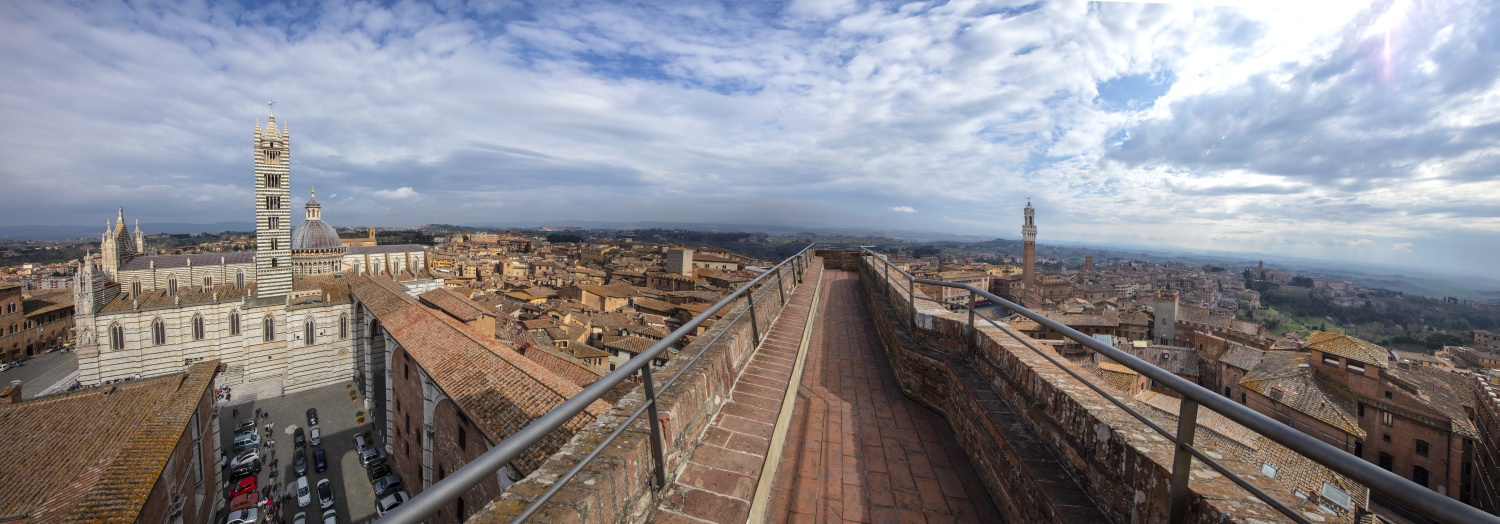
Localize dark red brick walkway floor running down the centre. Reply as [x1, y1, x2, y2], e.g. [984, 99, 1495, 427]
[768, 270, 1001, 522]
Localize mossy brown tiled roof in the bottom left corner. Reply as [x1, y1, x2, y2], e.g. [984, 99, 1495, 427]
[0, 360, 219, 522]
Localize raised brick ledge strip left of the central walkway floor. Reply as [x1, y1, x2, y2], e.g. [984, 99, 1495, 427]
[651, 258, 827, 522]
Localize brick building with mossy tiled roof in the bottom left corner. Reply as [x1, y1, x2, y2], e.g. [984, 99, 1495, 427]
[0, 360, 221, 522]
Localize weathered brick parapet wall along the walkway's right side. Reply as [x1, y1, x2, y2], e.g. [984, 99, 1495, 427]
[861, 252, 1316, 522]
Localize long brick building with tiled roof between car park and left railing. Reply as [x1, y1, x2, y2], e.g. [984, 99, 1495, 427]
[350, 276, 609, 522]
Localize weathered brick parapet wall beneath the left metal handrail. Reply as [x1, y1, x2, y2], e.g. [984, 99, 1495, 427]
[470, 258, 822, 522]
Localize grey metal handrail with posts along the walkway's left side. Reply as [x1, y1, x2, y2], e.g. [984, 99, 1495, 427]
[380, 243, 815, 524]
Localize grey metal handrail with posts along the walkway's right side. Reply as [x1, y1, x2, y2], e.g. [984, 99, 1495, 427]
[860, 246, 1500, 524]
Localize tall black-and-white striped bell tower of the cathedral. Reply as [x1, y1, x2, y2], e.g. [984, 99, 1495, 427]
[254, 102, 291, 299]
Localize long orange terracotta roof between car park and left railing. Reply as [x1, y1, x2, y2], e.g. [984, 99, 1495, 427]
[350, 276, 609, 474]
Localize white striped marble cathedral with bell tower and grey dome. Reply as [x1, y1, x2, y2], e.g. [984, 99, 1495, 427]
[74, 113, 443, 392]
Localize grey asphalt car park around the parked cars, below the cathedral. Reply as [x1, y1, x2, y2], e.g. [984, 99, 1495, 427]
[219, 383, 393, 522]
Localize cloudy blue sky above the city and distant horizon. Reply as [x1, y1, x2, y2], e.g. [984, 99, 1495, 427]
[0, 0, 1500, 275]
